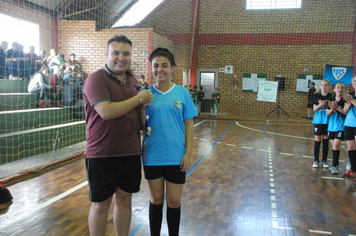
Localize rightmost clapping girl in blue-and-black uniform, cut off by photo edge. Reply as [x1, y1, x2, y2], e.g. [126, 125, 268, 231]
[343, 76, 356, 177]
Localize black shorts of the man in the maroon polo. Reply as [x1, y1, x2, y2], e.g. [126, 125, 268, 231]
[85, 156, 142, 202]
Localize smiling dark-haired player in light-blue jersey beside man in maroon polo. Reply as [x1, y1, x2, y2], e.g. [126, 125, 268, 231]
[142, 48, 198, 235]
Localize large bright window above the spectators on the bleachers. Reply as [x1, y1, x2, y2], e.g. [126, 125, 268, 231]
[0, 13, 40, 53]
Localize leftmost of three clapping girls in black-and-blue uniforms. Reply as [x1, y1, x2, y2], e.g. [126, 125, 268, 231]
[312, 80, 332, 169]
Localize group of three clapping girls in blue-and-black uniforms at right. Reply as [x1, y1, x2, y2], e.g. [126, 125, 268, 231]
[312, 76, 356, 177]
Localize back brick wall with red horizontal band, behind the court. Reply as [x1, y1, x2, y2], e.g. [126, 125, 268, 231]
[198, 0, 356, 117]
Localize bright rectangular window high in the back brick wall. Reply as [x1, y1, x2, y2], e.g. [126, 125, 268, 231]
[246, 0, 302, 10]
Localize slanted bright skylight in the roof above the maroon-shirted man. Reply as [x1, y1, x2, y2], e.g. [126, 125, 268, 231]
[111, 0, 163, 28]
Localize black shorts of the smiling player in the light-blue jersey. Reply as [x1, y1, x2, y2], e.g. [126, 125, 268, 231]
[143, 165, 186, 184]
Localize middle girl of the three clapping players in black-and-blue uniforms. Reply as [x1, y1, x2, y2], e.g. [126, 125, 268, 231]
[326, 83, 346, 175]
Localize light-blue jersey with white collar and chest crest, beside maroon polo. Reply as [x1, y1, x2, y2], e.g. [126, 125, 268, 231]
[142, 84, 198, 166]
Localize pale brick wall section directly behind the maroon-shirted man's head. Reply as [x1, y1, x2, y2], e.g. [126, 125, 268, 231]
[58, 20, 152, 77]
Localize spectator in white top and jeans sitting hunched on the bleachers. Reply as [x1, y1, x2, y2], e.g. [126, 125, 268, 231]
[28, 66, 52, 107]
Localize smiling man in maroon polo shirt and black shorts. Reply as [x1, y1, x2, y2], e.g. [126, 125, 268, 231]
[84, 35, 152, 236]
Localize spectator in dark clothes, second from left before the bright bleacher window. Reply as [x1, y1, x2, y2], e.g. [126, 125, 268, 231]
[5, 42, 20, 80]
